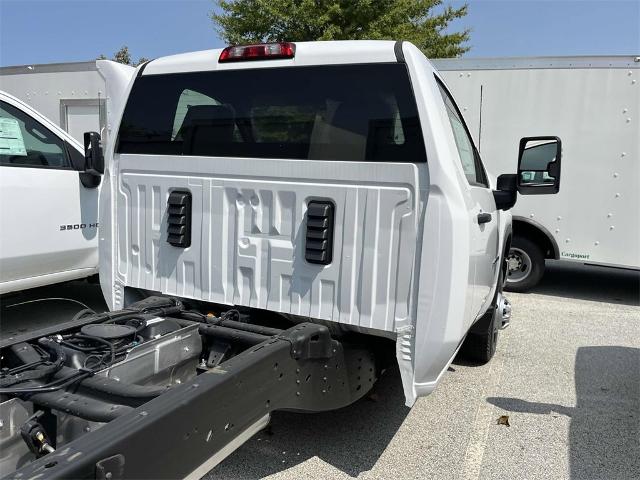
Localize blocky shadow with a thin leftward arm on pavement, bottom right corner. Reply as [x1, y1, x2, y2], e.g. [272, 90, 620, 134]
[487, 346, 640, 480]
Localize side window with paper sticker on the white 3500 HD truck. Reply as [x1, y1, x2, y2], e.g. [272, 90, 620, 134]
[0, 102, 70, 168]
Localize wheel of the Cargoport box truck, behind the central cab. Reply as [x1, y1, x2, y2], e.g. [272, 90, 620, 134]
[504, 236, 544, 292]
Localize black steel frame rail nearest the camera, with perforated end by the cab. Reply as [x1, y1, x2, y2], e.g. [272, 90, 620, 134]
[4, 323, 377, 480]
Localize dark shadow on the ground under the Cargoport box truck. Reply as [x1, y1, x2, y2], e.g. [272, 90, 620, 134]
[529, 261, 640, 306]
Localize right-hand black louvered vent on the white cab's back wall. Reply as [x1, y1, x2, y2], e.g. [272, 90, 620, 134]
[304, 200, 333, 265]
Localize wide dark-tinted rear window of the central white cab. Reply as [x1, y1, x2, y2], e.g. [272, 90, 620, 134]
[116, 63, 425, 162]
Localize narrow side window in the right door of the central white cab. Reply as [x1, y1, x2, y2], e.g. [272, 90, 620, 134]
[436, 79, 489, 187]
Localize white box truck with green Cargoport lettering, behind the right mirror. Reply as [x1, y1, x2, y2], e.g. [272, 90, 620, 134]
[434, 55, 640, 291]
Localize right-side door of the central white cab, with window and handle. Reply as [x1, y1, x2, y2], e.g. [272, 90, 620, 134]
[438, 82, 499, 322]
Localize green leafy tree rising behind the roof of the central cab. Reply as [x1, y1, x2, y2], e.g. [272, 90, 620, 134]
[211, 0, 470, 58]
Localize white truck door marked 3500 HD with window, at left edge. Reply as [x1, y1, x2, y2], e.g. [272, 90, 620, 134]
[0, 97, 98, 293]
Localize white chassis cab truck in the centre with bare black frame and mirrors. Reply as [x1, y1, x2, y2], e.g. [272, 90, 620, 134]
[0, 41, 561, 479]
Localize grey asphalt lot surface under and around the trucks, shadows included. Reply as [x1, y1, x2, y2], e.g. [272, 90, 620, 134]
[2, 264, 640, 480]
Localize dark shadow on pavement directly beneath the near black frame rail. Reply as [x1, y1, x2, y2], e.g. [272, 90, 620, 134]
[206, 368, 409, 480]
